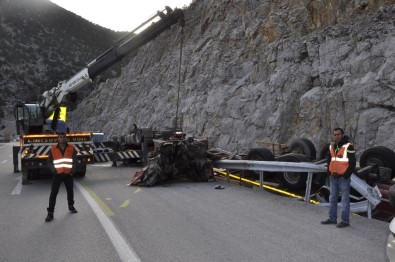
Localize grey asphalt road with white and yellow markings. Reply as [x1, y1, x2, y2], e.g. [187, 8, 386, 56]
[0, 144, 389, 262]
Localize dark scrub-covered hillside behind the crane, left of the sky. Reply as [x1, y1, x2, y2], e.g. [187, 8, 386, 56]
[0, 0, 124, 136]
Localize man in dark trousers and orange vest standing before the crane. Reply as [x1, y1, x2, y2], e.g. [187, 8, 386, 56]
[45, 133, 78, 222]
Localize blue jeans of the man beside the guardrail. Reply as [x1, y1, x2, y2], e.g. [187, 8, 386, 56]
[329, 176, 351, 224]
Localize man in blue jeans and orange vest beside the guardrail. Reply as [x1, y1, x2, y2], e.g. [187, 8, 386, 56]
[321, 127, 356, 228]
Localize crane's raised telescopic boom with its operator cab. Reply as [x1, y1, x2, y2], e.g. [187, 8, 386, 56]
[15, 6, 184, 135]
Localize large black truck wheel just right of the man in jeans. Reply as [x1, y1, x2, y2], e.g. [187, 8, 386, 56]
[359, 146, 395, 178]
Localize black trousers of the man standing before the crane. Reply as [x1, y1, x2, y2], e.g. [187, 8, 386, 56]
[47, 174, 74, 212]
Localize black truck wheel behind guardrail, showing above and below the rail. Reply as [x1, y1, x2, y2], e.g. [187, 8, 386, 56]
[276, 153, 311, 190]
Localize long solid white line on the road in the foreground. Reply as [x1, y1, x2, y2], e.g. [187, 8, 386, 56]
[74, 181, 141, 262]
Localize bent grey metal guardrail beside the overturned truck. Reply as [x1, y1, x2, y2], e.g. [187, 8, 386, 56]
[213, 160, 381, 218]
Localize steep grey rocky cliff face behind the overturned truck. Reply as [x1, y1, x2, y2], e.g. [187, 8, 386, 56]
[74, 0, 395, 157]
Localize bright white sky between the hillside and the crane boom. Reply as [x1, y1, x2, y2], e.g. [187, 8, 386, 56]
[50, 0, 192, 31]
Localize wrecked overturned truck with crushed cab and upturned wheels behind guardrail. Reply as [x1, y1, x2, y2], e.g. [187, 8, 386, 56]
[130, 135, 395, 217]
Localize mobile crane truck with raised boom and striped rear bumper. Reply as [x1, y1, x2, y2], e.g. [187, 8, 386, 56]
[13, 6, 184, 184]
